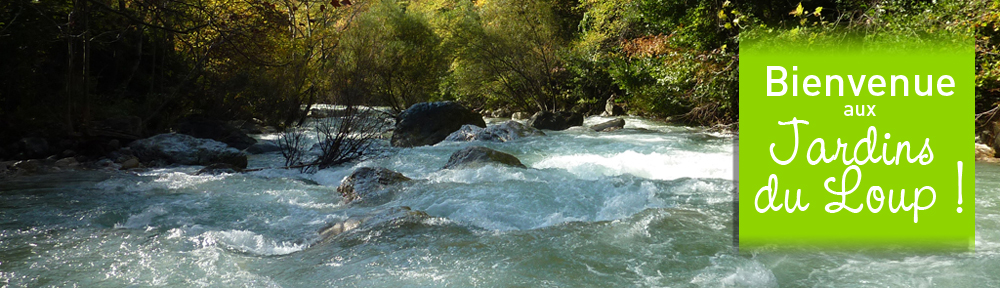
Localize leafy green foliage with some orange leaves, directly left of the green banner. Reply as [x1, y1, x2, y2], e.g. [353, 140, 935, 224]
[574, 0, 746, 124]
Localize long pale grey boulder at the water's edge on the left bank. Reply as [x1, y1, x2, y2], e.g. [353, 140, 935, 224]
[129, 133, 247, 169]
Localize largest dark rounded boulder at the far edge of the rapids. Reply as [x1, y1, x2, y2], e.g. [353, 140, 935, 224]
[391, 101, 486, 147]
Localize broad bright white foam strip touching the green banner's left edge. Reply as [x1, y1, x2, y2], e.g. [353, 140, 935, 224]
[532, 151, 733, 180]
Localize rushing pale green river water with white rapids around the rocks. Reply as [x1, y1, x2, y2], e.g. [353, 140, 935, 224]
[0, 117, 1000, 287]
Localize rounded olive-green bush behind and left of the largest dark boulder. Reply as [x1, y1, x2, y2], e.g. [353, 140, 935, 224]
[326, 0, 448, 111]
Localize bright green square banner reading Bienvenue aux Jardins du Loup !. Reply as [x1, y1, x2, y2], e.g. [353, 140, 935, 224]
[738, 39, 975, 249]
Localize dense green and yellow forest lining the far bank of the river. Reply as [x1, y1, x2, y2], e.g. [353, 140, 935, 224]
[0, 0, 1000, 144]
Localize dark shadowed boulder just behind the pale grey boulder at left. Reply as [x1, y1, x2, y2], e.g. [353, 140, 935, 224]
[176, 116, 257, 150]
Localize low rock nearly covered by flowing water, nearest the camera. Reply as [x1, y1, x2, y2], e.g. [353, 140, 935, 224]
[316, 206, 431, 244]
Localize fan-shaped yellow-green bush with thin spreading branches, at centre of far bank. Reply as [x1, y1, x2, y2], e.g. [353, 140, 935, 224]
[447, 0, 571, 111]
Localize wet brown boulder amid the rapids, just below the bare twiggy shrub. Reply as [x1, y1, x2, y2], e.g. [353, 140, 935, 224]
[337, 167, 410, 205]
